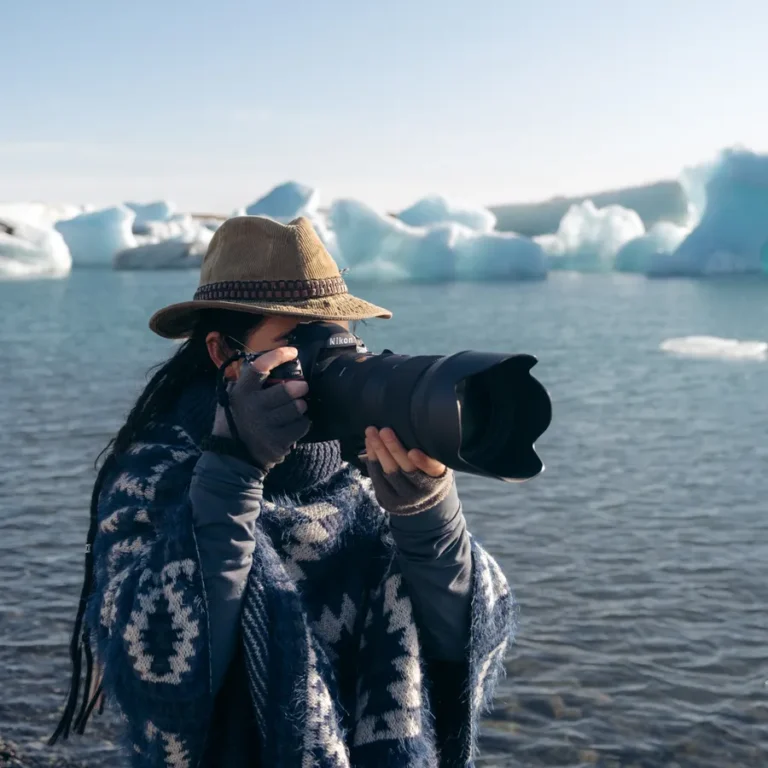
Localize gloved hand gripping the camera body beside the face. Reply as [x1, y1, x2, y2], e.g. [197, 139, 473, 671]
[213, 347, 310, 470]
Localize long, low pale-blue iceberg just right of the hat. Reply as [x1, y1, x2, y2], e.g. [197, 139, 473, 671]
[329, 200, 547, 282]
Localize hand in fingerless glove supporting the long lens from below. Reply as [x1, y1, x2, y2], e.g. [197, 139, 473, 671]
[365, 427, 453, 515]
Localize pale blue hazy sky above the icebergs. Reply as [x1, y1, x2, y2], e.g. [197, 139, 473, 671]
[0, 0, 768, 212]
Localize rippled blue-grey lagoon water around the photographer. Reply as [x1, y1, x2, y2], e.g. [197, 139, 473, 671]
[0, 271, 768, 768]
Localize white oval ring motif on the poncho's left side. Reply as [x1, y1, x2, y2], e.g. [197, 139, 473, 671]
[123, 559, 200, 685]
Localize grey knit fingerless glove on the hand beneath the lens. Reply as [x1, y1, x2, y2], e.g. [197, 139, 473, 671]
[365, 459, 453, 515]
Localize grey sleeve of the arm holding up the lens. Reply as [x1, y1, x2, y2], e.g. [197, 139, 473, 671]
[389, 483, 472, 661]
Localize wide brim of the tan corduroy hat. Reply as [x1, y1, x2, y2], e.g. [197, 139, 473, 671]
[149, 293, 392, 339]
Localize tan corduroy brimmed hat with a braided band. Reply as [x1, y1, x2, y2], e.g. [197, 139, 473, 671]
[149, 216, 392, 339]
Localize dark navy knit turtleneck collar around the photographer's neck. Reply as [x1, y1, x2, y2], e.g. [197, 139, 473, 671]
[172, 379, 343, 499]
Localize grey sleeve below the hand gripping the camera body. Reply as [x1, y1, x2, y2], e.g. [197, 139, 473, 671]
[189, 451, 264, 695]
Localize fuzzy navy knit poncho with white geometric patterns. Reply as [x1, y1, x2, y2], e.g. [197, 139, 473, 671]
[86, 404, 515, 768]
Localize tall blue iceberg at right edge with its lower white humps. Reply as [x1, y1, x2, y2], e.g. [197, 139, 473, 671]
[534, 149, 768, 277]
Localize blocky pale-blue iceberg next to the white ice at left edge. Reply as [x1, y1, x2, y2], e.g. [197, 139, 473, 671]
[56, 205, 138, 267]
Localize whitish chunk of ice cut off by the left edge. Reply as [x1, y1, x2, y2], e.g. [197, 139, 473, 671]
[0, 217, 72, 280]
